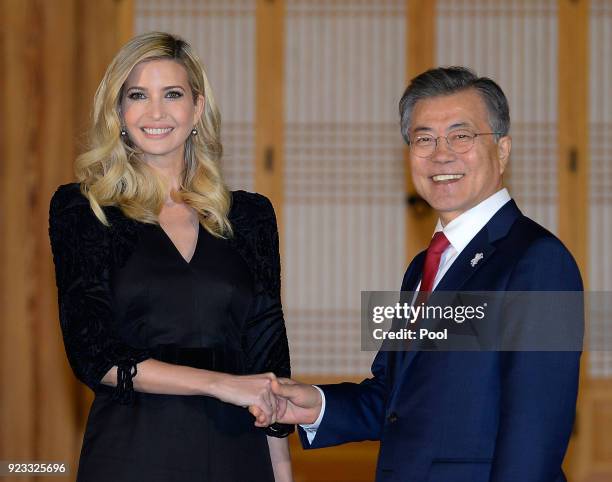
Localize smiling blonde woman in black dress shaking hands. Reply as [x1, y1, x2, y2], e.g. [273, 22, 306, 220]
[49, 32, 293, 482]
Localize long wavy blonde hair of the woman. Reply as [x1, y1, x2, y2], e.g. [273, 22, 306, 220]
[74, 32, 232, 237]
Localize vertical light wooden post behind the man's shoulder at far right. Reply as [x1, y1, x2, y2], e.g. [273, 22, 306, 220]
[558, 0, 592, 480]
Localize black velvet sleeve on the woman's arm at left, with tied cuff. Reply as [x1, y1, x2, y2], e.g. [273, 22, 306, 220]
[49, 184, 149, 403]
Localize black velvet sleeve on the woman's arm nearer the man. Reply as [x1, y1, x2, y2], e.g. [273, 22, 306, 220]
[234, 191, 294, 437]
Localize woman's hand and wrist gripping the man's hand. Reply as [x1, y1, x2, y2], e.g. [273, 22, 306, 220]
[210, 373, 277, 426]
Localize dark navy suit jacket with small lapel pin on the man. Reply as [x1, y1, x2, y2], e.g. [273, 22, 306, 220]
[300, 201, 584, 482]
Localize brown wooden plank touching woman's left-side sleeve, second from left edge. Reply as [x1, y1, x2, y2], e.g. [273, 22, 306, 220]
[36, 0, 79, 468]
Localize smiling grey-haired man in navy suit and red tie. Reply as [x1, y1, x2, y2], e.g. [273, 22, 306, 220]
[252, 67, 583, 482]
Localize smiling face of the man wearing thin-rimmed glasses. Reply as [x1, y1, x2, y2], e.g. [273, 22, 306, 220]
[408, 89, 511, 224]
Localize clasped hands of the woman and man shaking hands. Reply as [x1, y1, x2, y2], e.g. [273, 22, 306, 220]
[219, 373, 322, 427]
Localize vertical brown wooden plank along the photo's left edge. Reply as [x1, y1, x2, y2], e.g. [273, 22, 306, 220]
[0, 1, 37, 466]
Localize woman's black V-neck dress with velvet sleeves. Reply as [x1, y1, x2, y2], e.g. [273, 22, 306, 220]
[49, 184, 292, 482]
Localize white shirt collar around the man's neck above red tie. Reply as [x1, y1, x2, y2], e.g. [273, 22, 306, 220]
[434, 188, 511, 253]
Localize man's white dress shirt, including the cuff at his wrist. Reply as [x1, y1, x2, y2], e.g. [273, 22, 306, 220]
[300, 188, 511, 443]
